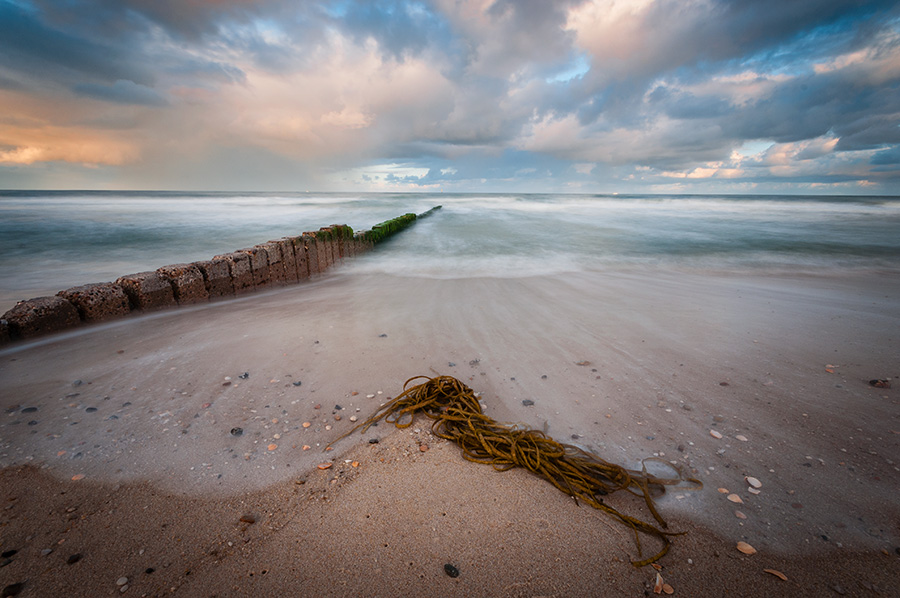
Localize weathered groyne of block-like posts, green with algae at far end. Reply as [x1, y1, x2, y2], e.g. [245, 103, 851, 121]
[0, 206, 441, 345]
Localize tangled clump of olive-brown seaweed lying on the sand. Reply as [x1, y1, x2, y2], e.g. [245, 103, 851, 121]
[338, 376, 702, 567]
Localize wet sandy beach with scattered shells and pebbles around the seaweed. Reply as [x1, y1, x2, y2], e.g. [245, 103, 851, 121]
[0, 267, 900, 596]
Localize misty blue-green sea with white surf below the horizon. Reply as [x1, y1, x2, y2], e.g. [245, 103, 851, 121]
[0, 191, 900, 312]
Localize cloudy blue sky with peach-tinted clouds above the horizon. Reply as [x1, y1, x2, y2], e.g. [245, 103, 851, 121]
[0, 0, 900, 195]
